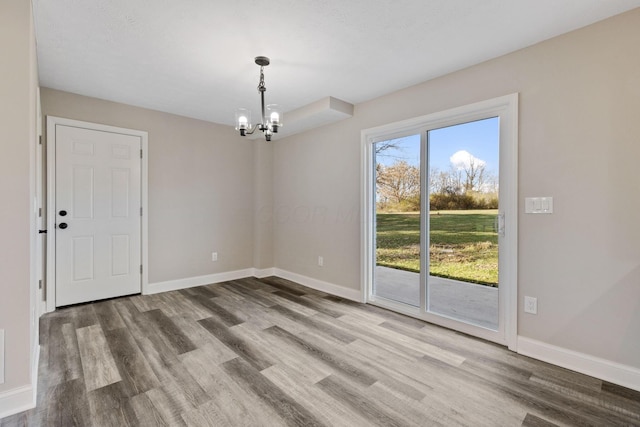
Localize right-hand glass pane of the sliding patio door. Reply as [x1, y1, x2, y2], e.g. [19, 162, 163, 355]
[425, 117, 500, 331]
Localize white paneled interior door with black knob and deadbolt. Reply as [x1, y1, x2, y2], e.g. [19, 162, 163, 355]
[53, 124, 142, 306]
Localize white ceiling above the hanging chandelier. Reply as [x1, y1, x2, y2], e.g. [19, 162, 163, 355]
[33, 0, 640, 127]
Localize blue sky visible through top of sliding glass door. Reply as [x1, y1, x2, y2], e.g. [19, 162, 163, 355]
[376, 117, 499, 175]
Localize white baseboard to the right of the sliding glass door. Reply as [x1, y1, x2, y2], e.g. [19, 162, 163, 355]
[518, 337, 640, 391]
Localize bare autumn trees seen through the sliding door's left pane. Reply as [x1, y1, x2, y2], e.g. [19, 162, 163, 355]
[376, 160, 420, 203]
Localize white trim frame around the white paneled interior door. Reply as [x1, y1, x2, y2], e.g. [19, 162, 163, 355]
[46, 116, 149, 312]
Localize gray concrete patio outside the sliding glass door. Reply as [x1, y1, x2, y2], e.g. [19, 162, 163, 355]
[374, 266, 499, 330]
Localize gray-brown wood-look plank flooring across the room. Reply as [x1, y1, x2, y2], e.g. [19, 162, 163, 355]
[0, 278, 640, 427]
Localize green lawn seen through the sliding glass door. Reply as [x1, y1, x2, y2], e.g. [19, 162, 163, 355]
[376, 210, 498, 286]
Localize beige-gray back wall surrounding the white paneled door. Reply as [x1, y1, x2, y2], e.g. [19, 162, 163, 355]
[41, 88, 256, 283]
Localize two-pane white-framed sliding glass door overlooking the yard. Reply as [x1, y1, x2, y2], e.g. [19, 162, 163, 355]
[363, 94, 517, 344]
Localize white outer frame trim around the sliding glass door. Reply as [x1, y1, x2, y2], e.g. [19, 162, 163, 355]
[360, 93, 518, 351]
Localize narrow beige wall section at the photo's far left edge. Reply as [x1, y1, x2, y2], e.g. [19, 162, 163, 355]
[0, 0, 38, 393]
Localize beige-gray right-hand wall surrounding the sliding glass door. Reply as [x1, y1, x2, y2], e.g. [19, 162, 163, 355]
[273, 9, 640, 368]
